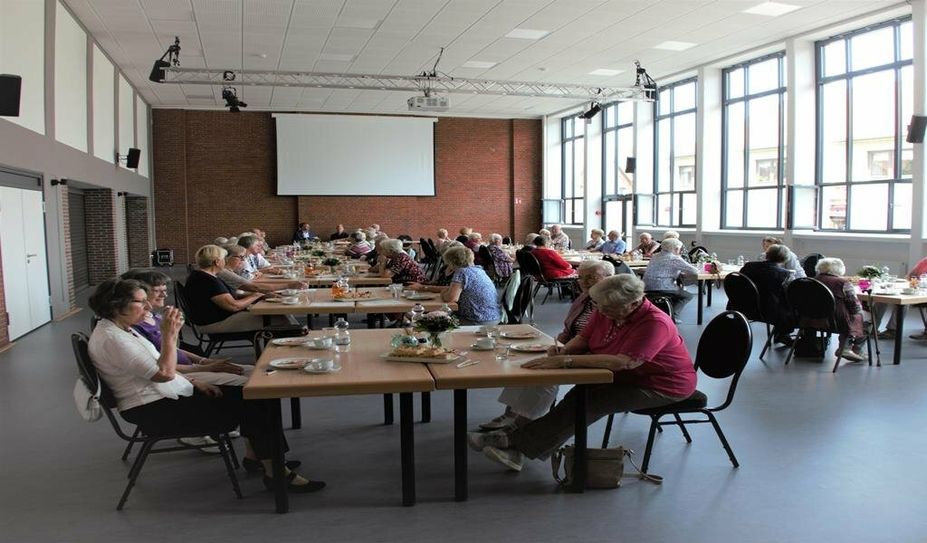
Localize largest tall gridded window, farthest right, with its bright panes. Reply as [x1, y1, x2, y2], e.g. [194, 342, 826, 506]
[816, 19, 914, 232]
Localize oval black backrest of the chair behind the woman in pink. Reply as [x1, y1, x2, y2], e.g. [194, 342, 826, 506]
[695, 311, 753, 411]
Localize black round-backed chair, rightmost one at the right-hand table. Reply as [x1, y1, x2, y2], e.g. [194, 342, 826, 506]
[785, 277, 872, 373]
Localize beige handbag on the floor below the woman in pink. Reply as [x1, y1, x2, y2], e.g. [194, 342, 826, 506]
[550, 445, 663, 488]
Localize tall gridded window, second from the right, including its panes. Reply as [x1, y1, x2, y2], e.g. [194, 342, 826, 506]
[721, 53, 785, 229]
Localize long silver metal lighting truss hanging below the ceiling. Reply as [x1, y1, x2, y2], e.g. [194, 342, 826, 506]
[163, 67, 652, 102]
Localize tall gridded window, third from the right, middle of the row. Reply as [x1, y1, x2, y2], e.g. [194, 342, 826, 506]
[652, 79, 696, 226]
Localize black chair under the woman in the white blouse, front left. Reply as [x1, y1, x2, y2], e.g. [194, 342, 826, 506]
[71, 332, 242, 511]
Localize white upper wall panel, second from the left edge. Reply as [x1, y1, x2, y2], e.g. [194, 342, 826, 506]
[55, 3, 87, 151]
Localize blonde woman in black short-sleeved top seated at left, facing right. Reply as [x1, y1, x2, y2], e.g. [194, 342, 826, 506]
[184, 245, 264, 333]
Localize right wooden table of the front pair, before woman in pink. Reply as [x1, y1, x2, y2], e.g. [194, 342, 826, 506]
[428, 324, 613, 501]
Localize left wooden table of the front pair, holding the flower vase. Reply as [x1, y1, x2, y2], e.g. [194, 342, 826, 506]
[244, 330, 434, 513]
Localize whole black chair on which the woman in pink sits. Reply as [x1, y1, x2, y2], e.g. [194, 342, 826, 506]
[602, 311, 753, 473]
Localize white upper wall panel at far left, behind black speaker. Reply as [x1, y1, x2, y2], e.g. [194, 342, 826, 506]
[0, 0, 45, 134]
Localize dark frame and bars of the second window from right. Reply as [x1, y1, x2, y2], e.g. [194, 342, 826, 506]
[720, 51, 788, 231]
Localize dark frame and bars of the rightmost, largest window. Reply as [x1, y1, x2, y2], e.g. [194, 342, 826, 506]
[814, 16, 914, 234]
